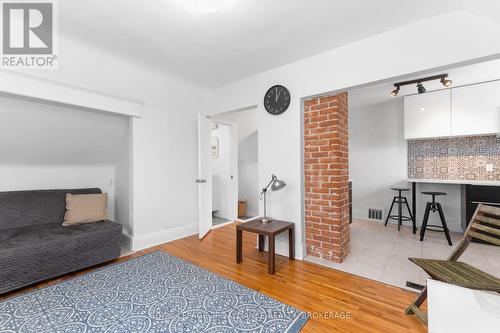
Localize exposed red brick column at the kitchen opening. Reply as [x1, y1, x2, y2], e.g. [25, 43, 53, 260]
[304, 93, 349, 262]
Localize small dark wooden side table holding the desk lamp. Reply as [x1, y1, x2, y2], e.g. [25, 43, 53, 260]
[236, 220, 295, 274]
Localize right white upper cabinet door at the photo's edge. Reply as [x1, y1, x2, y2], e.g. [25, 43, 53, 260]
[451, 81, 500, 136]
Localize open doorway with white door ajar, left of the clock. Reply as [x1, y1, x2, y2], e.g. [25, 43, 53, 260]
[197, 107, 259, 238]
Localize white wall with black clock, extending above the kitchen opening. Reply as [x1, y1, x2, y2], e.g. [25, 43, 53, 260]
[210, 11, 500, 258]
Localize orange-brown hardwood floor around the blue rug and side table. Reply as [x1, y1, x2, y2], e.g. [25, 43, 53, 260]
[0, 225, 427, 333]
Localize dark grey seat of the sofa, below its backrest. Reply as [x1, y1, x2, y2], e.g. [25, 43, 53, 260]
[0, 221, 121, 294]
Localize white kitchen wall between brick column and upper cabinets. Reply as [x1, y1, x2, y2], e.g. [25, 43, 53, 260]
[349, 97, 411, 218]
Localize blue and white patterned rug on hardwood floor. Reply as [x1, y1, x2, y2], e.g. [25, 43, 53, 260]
[0, 252, 307, 333]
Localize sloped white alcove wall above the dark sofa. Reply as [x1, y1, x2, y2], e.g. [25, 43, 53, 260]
[0, 97, 128, 165]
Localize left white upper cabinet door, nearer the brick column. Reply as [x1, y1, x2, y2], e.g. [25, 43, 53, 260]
[404, 89, 451, 140]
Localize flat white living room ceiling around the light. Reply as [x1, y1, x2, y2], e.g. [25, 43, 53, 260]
[58, 0, 478, 87]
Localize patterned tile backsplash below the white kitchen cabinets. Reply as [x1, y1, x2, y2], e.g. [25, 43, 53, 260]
[408, 135, 500, 180]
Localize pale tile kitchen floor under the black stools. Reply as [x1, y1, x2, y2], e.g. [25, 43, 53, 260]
[306, 219, 500, 288]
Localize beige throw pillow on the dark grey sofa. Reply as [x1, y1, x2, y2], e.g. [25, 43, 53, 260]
[63, 193, 108, 226]
